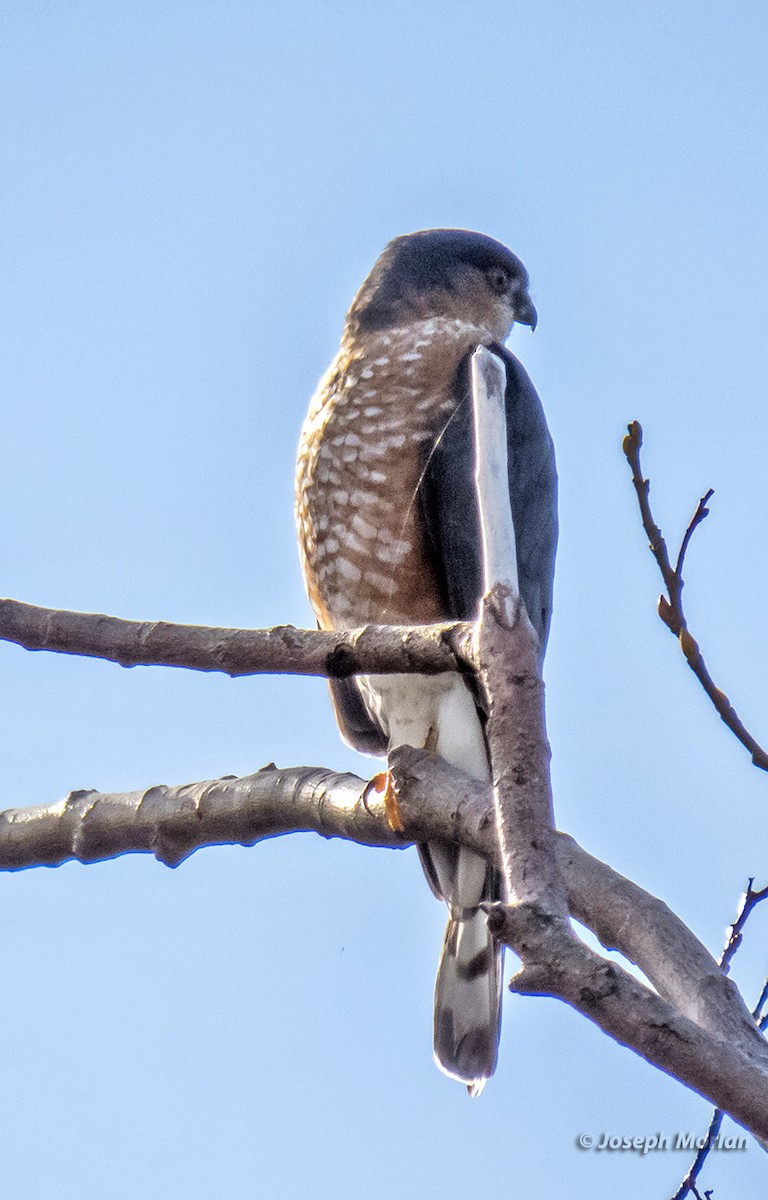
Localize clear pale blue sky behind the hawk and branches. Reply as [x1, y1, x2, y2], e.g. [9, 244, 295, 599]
[0, 0, 768, 1200]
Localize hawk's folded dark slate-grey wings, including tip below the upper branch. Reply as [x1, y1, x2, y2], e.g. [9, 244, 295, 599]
[329, 346, 557, 754]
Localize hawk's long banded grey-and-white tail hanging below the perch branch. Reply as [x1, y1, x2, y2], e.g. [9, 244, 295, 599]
[421, 844, 504, 1096]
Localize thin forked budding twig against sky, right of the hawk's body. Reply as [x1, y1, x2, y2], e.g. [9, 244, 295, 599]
[623, 421, 768, 770]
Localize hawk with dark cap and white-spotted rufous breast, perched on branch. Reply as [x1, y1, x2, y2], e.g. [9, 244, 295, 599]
[296, 229, 557, 1094]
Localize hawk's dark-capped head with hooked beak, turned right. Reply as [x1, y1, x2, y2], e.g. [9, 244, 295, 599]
[347, 229, 536, 342]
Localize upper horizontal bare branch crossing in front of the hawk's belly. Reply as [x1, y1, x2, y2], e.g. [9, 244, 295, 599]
[0, 600, 472, 679]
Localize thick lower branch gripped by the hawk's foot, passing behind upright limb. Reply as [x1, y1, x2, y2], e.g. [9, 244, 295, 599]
[0, 746, 738, 1051]
